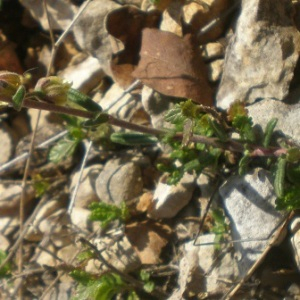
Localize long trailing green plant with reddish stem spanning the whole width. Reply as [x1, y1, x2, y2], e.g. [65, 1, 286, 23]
[0, 72, 300, 210]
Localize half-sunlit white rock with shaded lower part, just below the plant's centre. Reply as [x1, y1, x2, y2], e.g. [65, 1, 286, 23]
[148, 174, 196, 219]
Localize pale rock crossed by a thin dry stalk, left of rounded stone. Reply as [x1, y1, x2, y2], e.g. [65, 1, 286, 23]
[70, 164, 103, 208]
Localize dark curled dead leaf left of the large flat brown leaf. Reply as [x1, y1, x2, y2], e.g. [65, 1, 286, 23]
[106, 6, 160, 88]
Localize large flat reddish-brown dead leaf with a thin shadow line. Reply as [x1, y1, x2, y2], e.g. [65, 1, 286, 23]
[132, 28, 213, 106]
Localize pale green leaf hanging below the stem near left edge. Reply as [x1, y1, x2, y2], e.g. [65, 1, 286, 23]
[49, 139, 78, 163]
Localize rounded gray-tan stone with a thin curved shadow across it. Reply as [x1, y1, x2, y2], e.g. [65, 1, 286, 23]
[95, 159, 143, 205]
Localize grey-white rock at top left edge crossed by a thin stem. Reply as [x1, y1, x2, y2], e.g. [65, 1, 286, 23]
[20, 0, 78, 30]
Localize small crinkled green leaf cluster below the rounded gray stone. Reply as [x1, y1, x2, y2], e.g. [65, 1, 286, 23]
[89, 202, 129, 228]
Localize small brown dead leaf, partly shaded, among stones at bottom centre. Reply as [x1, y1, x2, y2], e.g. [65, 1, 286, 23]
[125, 220, 172, 264]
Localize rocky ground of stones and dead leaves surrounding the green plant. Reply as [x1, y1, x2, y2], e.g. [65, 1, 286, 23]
[0, 0, 300, 300]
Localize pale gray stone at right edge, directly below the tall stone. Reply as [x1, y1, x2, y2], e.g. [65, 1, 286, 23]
[247, 99, 300, 144]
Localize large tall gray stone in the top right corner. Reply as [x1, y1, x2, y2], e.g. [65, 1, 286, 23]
[217, 0, 300, 109]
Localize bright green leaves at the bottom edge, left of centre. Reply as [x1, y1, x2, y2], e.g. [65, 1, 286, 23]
[69, 270, 128, 300]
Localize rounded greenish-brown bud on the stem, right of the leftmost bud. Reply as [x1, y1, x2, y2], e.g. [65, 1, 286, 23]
[34, 76, 71, 105]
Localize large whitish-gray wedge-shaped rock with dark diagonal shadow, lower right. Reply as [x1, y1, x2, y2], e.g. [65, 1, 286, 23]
[219, 168, 284, 276]
